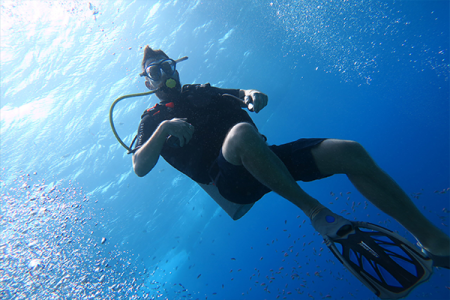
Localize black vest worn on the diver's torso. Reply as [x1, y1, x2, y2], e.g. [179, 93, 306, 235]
[136, 84, 256, 184]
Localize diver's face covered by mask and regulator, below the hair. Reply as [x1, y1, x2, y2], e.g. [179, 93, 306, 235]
[145, 56, 180, 90]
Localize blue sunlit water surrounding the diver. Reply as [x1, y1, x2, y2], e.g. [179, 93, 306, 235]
[0, 0, 450, 299]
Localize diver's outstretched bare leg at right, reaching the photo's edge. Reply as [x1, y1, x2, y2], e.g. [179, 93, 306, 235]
[311, 140, 450, 255]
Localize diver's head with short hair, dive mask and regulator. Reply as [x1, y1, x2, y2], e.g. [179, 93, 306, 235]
[140, 45, 181, 100]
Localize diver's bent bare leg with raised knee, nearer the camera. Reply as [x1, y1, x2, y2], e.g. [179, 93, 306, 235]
[222, 123, 323, 217]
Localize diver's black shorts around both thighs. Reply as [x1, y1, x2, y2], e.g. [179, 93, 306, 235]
[209, 138, 330, 204]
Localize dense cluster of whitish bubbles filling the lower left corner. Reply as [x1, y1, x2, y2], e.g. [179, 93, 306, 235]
[0, 170, 151, 299]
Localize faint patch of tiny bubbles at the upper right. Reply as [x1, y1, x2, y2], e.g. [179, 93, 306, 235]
[270, 0, 449, 84]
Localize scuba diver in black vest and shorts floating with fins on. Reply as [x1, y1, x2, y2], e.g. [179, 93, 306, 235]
[120, 46, 450, 299]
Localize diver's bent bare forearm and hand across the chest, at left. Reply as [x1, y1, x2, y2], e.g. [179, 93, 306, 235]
[133, 118, 194, 177]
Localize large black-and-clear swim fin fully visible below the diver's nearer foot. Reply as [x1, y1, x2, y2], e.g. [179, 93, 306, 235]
[312, 208, 433, 299]
